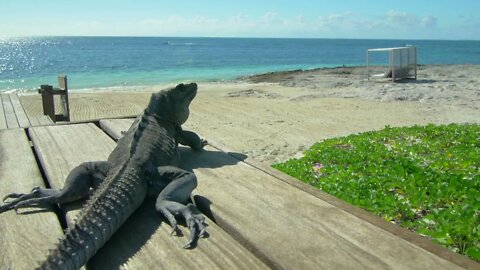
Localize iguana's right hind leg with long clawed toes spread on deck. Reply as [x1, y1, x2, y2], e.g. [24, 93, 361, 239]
[148, 166, 206, 248]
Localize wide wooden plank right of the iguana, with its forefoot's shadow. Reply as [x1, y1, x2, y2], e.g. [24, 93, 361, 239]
[97, 120, 468, 269]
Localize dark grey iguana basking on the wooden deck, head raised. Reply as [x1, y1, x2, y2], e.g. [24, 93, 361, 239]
[0, 83, 207, 269]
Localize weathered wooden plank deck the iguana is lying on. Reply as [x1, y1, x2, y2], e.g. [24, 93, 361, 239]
[0, 119, 480, 269]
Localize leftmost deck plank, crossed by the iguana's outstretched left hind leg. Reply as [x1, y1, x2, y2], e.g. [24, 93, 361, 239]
[0, 129, 62, 269]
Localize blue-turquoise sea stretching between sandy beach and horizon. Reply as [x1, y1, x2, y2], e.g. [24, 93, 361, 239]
[0, 37, 480, 92]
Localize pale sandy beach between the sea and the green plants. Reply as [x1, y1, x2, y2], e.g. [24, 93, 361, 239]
[21, 65, 480, 165]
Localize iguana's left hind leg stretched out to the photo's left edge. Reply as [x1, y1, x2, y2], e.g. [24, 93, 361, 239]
[0, 161, 110, 213]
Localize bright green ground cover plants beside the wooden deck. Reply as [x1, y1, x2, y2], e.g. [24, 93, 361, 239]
[273, 124, 480, 261]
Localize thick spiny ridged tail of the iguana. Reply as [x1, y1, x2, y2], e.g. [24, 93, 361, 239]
[38, 164, 146, 269]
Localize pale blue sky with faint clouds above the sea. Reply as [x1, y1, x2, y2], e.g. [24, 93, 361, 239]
[0, 0, 480, 40]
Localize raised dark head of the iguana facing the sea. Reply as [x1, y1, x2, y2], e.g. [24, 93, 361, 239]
[146, 83, 197, 125]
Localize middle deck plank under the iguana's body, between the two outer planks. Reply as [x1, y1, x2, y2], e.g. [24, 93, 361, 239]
[30, 124, 267, 269]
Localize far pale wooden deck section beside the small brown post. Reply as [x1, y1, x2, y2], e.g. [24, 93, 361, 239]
[0, 93, 53, 129]
